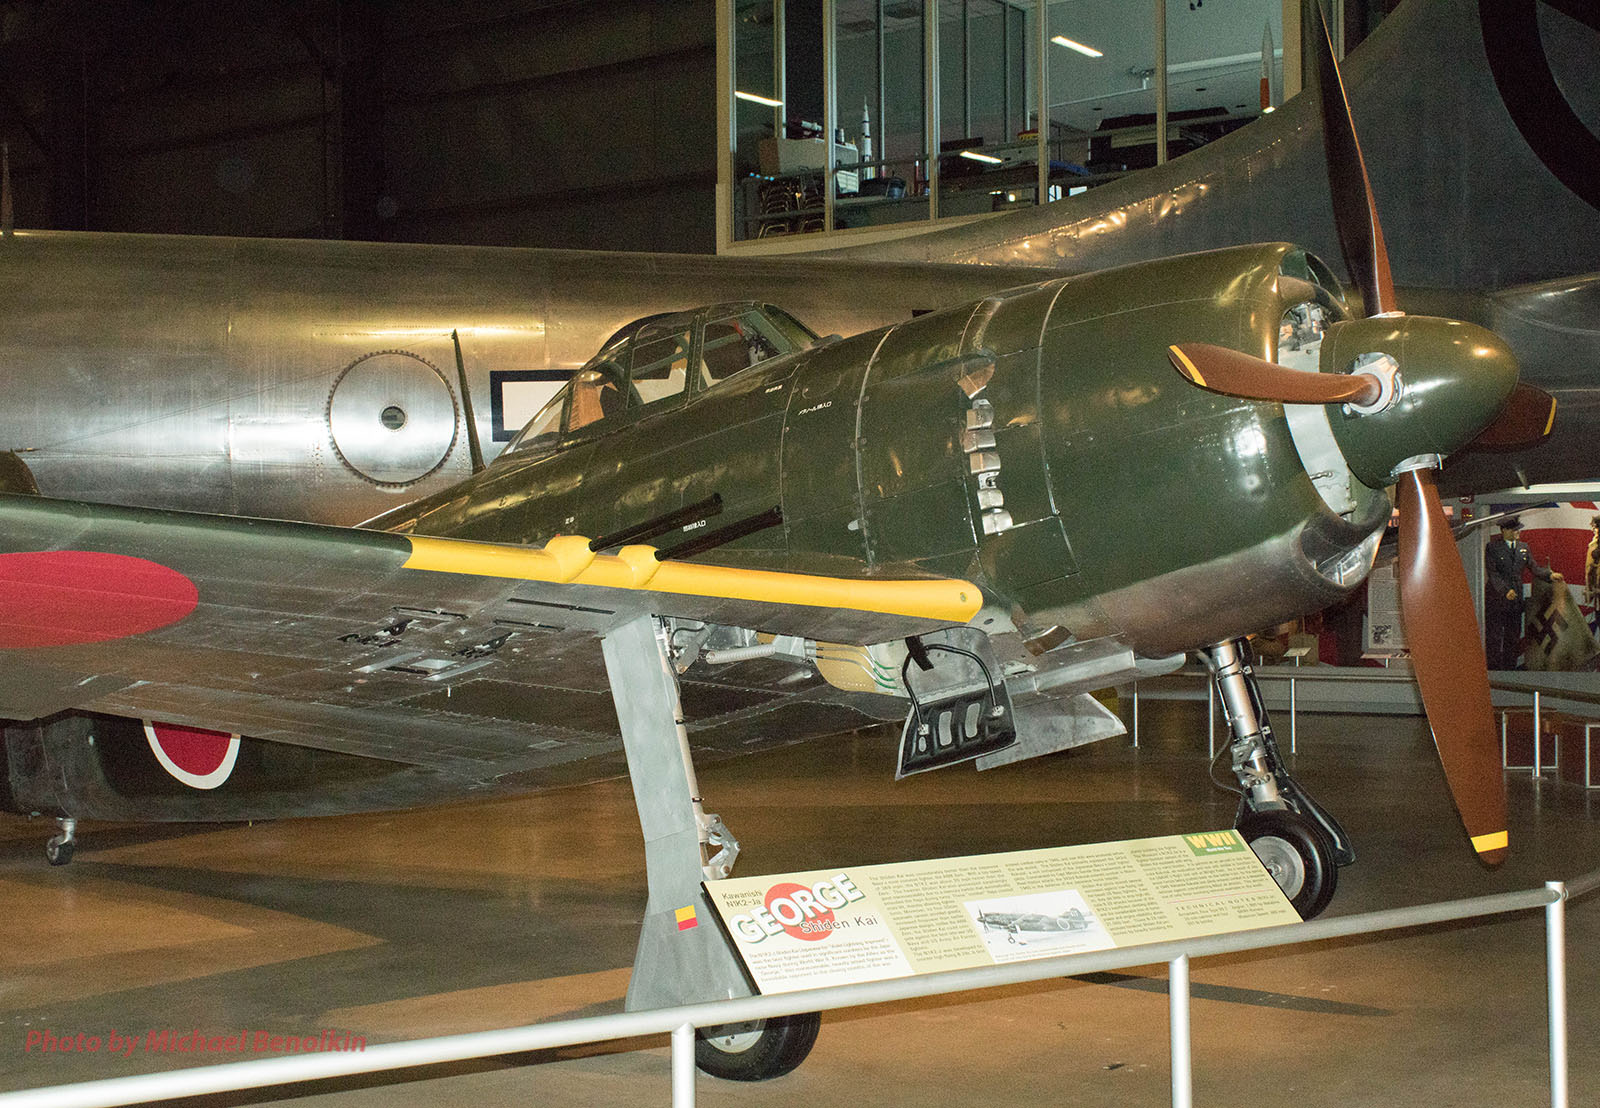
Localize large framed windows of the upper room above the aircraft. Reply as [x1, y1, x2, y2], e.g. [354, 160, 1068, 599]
[720, 0, 1299, 242]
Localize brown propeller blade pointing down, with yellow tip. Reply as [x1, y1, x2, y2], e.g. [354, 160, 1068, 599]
[1395, 469, 1507, 865]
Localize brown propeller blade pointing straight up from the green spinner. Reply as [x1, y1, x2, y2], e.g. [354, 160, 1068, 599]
[1306, 0, 1395, 315]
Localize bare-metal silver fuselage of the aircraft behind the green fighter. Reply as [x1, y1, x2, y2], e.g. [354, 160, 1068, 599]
[0, 232, 1040, 524]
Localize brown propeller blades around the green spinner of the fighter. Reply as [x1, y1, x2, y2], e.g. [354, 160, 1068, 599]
[1168, 3, 1523, 865]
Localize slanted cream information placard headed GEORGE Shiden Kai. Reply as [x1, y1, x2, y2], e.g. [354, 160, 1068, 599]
[706, 829, 1299, 993]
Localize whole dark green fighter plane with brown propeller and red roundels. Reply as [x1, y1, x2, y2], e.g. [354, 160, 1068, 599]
[0, 17, 1549, 1078]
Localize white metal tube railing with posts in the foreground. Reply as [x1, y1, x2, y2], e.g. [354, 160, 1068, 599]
[0, 869, 1600, 1108]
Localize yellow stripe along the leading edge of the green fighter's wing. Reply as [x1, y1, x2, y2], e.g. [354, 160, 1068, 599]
[405, 535, 982, 623]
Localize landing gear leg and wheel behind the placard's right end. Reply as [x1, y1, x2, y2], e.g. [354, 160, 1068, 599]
[1205, 639, 1355, 919]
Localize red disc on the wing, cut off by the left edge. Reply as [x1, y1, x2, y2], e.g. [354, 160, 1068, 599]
[0, 551, 200, 648]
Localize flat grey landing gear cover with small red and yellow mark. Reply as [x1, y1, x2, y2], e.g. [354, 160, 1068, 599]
[602, 615, 752, 1012]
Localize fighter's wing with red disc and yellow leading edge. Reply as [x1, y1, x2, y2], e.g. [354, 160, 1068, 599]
[0, 496, 982, 810]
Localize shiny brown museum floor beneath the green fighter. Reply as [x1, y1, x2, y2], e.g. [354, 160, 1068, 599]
[0, 701, 1600, 1108]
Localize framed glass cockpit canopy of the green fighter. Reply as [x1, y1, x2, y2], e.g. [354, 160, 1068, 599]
[506, 301, 816, 455]
